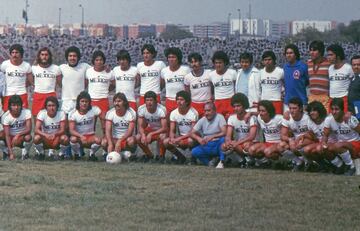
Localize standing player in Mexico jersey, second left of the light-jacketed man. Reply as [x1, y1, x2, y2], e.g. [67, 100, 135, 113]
[184, 53, 213, 118]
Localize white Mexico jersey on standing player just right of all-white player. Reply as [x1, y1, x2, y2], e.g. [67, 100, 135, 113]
[85, 67, 114, 99]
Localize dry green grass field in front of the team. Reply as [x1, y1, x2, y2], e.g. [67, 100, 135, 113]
[0, 157, 360, 230]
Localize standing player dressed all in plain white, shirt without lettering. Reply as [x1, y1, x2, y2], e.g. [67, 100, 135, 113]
[60, 46, 90, 114]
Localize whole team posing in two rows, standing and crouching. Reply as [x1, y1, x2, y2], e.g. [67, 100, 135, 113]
[0, 41, 360, 176]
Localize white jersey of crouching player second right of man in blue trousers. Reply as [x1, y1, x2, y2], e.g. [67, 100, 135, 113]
[258, 115, 283, 143]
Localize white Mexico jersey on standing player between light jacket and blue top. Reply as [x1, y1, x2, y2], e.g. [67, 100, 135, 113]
[260, 67, 284, 101]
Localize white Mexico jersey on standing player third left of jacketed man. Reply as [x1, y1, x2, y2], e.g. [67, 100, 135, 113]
[161, 66, 190, 100]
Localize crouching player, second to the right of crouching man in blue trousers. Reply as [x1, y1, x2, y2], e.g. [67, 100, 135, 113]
[249, 100, 283, 167]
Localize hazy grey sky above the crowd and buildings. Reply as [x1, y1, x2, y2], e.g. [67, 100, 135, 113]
[0, 0, 360, 25]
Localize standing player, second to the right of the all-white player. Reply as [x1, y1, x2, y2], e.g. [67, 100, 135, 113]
[113, 50, 140, 111]
